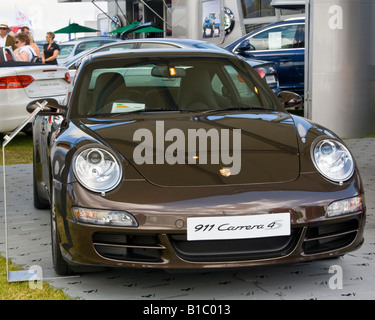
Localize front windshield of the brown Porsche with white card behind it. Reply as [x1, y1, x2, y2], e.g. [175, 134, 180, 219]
[71, 57, 278, 117]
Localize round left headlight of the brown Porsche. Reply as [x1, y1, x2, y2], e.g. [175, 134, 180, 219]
[73, 148, 122, 192]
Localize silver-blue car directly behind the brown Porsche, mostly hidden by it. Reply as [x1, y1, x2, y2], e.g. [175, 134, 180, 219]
[64, 38, 280, 94]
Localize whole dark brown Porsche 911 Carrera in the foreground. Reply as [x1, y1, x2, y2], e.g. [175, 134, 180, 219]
[28, 49, 366, 274]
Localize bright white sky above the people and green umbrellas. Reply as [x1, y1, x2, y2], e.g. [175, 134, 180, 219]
[0, 0, 107, 42]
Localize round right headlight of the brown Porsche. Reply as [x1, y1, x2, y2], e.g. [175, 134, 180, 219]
[312, 139, 354, 182]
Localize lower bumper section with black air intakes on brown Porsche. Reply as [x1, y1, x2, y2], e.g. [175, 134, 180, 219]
[64, 213, 364, 269]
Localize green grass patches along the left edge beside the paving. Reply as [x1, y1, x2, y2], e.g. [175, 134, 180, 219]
[0, 133, 70, 300]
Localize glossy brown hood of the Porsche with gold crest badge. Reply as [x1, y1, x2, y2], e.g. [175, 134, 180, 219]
[81, 112, 300, 187]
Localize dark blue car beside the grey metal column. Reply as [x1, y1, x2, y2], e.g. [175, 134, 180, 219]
[226, 19, 305, 95]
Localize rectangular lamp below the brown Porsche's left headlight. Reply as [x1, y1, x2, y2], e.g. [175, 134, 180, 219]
[73, 208, 138, 227]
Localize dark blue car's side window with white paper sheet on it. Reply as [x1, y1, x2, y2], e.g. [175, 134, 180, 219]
[249, 25, 298, 50]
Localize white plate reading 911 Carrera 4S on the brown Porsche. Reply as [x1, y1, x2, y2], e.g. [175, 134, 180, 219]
[187, 212, 290, 241]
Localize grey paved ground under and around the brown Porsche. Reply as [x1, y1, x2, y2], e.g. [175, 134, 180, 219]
[0, 138, 375, 300]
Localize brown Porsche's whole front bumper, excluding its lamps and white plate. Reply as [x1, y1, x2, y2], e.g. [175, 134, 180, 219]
[56, 171, 366, 269]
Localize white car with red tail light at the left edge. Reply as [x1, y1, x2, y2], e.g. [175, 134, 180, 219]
[0, 48, 71, 134]
